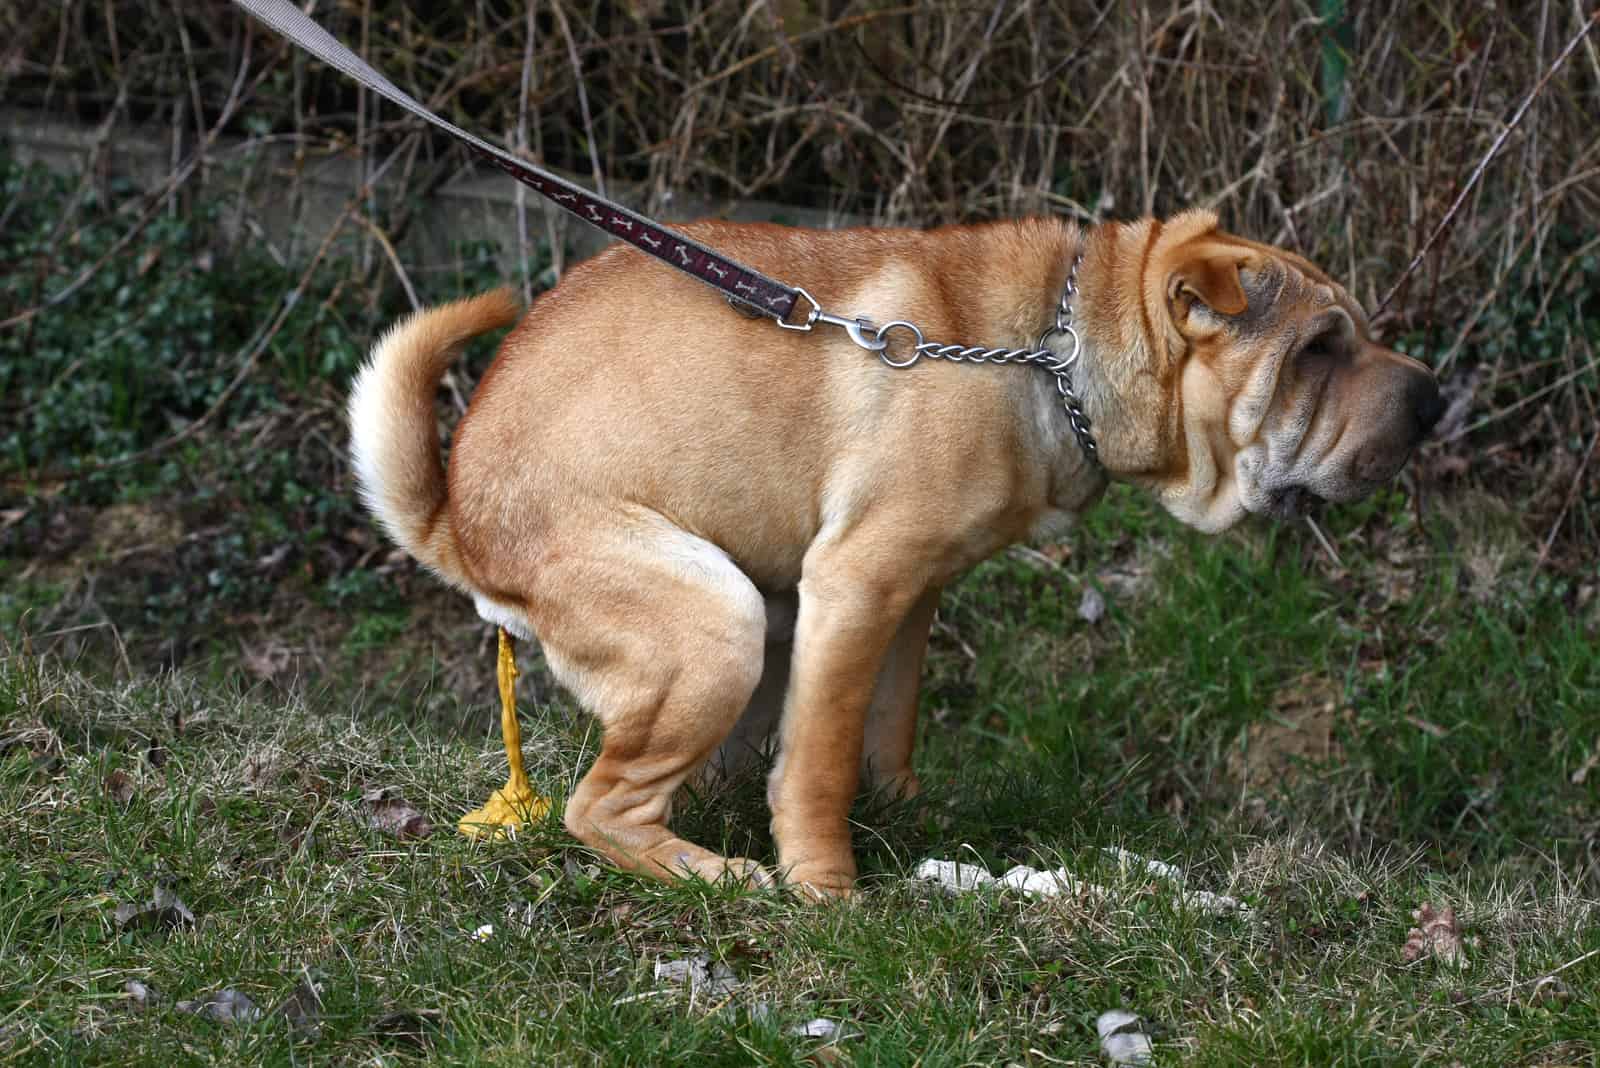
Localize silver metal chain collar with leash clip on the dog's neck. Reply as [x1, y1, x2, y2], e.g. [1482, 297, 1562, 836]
[778, 253, 1099, 465]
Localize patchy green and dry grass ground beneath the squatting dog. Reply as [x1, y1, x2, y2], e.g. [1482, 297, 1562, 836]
[0, 479, 1600, 1065]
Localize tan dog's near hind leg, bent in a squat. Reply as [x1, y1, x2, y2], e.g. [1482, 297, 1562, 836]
[528, 513, 770, 884]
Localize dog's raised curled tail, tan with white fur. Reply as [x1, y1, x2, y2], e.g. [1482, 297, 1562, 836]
[349, 289, 522, 585]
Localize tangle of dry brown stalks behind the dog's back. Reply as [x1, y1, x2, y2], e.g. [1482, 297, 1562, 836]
[9, 0, 1600, 549]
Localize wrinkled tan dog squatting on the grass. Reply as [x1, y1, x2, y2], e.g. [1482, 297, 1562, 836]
[350, 211, 1440, 894]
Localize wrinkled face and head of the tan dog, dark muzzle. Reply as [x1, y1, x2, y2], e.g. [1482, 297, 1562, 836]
[1158, 222, 1443, 531]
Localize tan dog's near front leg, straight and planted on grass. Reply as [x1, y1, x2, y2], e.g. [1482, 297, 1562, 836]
[766, 532, 923, 897]
